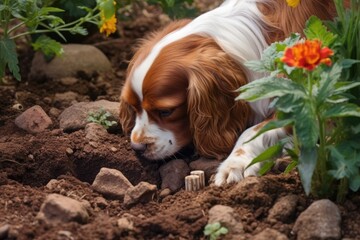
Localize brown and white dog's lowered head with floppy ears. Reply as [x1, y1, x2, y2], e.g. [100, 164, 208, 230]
[120, 21, 251, 159]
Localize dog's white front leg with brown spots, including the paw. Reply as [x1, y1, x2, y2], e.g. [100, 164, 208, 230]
[215, 123, 287, 186]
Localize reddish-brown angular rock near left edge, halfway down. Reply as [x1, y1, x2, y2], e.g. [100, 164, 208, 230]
[15, 105, 52, 133]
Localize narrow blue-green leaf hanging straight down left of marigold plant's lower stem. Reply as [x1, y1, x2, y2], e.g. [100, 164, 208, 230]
[298, 147, 317, 195]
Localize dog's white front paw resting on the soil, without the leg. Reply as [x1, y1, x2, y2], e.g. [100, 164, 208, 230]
[215, 156, 260, 186]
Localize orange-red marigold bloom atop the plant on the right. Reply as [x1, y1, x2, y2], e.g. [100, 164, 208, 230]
[281, 40, 334, 71]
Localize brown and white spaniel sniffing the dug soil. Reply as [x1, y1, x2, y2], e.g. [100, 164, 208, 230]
[120, 0, 344, 185]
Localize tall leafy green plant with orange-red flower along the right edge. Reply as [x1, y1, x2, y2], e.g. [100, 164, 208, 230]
[238, 0, 360, 201]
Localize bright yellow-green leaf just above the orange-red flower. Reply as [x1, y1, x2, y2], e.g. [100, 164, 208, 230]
[304, 16, 337, 46]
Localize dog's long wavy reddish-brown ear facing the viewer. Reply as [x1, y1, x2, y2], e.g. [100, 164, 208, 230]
[188, 44, 251, 159]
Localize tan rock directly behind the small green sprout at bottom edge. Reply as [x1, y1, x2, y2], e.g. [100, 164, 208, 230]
[208, 205, 244, 235]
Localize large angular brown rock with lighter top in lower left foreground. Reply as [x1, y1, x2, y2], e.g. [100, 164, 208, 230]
[37, 194, 89, 224]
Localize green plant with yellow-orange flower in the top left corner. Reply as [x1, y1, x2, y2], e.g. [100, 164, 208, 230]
[0, 0, 115, 80]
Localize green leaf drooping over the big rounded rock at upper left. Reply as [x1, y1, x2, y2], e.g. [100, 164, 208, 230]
[32, 35, 64, 57]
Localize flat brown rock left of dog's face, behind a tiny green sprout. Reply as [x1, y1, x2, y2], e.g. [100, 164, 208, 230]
[59, 100, 119, 132]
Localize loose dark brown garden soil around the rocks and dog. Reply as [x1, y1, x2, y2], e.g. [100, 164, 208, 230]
[0, 3, 360, 239]
